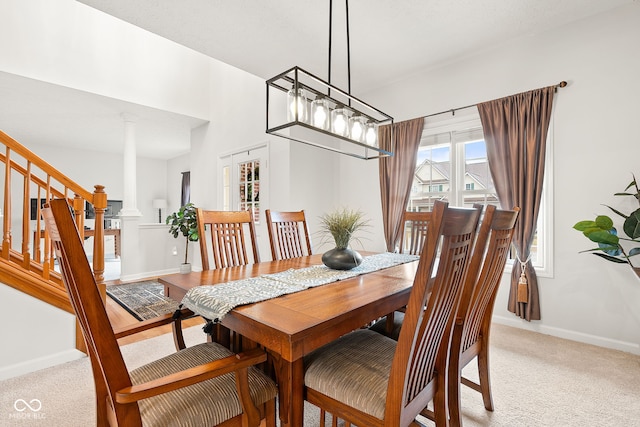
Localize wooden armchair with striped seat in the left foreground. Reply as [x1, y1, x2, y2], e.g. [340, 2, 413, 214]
[42, 199, 277, 427]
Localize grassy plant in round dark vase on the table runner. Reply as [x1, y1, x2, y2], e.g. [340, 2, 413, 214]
[320, 208, 369, 270]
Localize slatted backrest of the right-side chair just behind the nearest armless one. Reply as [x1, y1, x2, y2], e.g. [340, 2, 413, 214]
[456, 205, 520, 360]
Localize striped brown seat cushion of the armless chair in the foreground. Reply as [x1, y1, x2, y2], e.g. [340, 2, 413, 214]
[304, 329, 397, 419]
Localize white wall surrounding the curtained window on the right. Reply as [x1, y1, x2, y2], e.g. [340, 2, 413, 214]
[341, 3, 640, 354]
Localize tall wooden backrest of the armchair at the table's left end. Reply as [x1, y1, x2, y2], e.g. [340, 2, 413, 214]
[42, 199, 140, 424]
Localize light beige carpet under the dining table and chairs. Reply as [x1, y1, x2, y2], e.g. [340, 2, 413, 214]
[0, 325, 640, 427]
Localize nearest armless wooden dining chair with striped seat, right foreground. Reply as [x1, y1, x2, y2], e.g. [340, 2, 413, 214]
[304, 201, 480, 427]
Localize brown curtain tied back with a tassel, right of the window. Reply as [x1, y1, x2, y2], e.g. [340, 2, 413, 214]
[478, 86, 555, 321]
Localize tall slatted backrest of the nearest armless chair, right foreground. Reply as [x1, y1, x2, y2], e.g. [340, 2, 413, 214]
[385, 201, 481, 425]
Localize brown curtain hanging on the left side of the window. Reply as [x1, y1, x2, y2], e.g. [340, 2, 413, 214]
[378, 118, 424, 252]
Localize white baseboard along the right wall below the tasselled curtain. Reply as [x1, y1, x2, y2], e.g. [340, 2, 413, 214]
[492, 315, 640, 355]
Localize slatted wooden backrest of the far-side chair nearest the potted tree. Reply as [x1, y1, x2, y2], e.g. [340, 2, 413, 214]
[196, 208, 260, 270]
